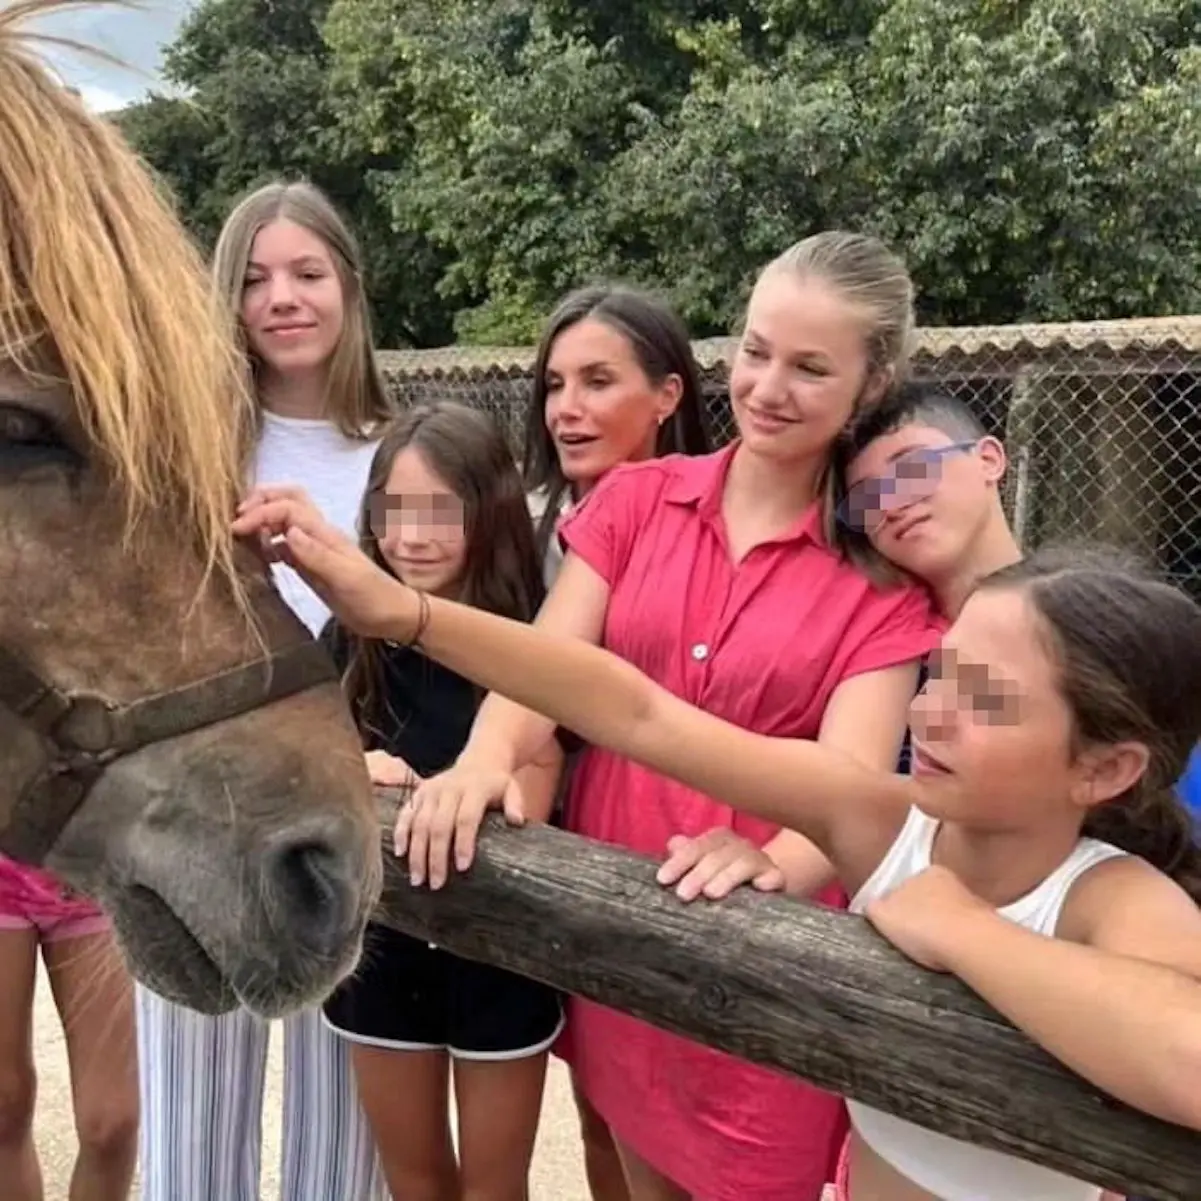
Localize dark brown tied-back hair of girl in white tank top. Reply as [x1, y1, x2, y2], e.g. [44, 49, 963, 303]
[980, 546, 1201, 903]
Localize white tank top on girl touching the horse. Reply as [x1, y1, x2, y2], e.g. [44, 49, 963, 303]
[847, 808, 1125, 1201]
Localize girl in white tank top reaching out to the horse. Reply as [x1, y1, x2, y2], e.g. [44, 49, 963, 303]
[235, 497, 1201, 1201]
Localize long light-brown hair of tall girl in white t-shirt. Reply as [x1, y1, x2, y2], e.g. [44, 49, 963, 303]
[213, 181, 395, 449]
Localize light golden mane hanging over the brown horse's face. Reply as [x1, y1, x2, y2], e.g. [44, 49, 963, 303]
[0, 0, 253, 603]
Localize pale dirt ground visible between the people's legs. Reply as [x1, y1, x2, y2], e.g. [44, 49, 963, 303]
[34, 955, 587, 1201]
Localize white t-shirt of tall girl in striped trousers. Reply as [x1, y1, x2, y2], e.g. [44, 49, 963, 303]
[255, 412, 380, 637]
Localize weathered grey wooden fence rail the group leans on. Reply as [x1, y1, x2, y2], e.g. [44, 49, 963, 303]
[377, 789, 1201, 1201]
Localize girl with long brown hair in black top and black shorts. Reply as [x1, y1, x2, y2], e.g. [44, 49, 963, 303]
[323, 402, 563, 1201]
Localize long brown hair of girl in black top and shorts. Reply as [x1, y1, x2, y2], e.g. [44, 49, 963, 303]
[339, 401, 545, 730]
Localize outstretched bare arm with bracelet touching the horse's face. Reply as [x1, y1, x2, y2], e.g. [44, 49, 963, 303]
[234, 489, 912, 885]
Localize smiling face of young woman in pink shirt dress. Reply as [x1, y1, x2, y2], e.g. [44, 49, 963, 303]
[730, 270, 883, 464]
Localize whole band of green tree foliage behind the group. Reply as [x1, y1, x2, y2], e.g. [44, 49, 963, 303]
[117, 0, 1201, 345]
